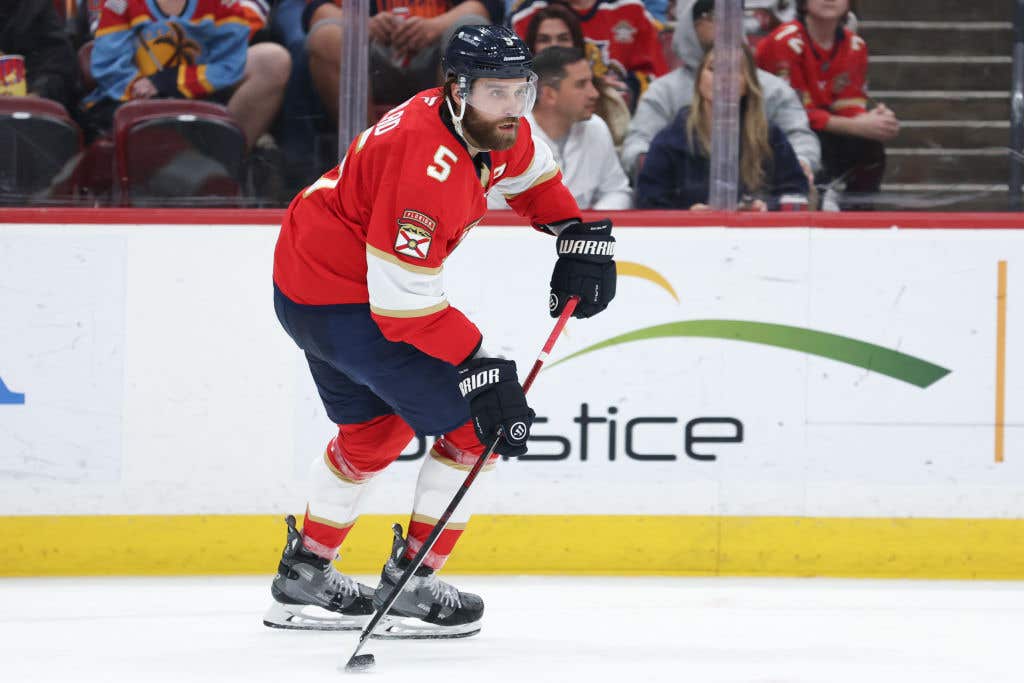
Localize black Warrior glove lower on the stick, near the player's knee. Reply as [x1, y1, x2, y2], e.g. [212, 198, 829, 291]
[458, 358, 537, 457]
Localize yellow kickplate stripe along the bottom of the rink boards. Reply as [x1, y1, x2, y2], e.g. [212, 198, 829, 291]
[0, 515, 1024, 580]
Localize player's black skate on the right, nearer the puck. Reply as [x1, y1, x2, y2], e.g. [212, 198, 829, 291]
[374, 524, 483, 639]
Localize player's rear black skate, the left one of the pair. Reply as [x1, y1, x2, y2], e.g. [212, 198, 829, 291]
[263, 515, 374, 631]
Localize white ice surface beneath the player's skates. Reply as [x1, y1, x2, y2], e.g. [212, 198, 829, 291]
[0, 575, 1024, 683]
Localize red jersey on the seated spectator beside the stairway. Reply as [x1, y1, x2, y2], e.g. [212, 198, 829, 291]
[757, 22, 867, 130]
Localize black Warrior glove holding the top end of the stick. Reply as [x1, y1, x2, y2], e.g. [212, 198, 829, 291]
[548, 220, 615, 317]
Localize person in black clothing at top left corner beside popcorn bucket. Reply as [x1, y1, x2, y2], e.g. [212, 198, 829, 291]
[0, 0, 76, 109]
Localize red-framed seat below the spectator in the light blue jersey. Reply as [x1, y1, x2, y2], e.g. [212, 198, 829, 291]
[114, 99, 246, 206]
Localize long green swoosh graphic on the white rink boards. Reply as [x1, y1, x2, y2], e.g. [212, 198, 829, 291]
[550, 321, 950, 389]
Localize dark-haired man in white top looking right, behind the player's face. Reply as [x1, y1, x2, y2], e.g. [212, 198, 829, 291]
[487, 47, 633, 211]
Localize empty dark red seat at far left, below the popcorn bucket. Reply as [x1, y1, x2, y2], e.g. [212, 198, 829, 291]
[0, 97, 82, 205]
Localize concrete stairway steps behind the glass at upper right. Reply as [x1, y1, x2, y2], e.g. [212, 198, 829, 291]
[815, 0, 1015, 212]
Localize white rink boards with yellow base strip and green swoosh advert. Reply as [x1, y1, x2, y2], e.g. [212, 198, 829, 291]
[0, 214, 1024, 578]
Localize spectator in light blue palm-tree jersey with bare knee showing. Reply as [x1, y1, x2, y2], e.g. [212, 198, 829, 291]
[83, 0, 291, 145]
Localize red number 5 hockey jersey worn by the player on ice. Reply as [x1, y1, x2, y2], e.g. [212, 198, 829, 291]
[273, 88, 580, 365]
